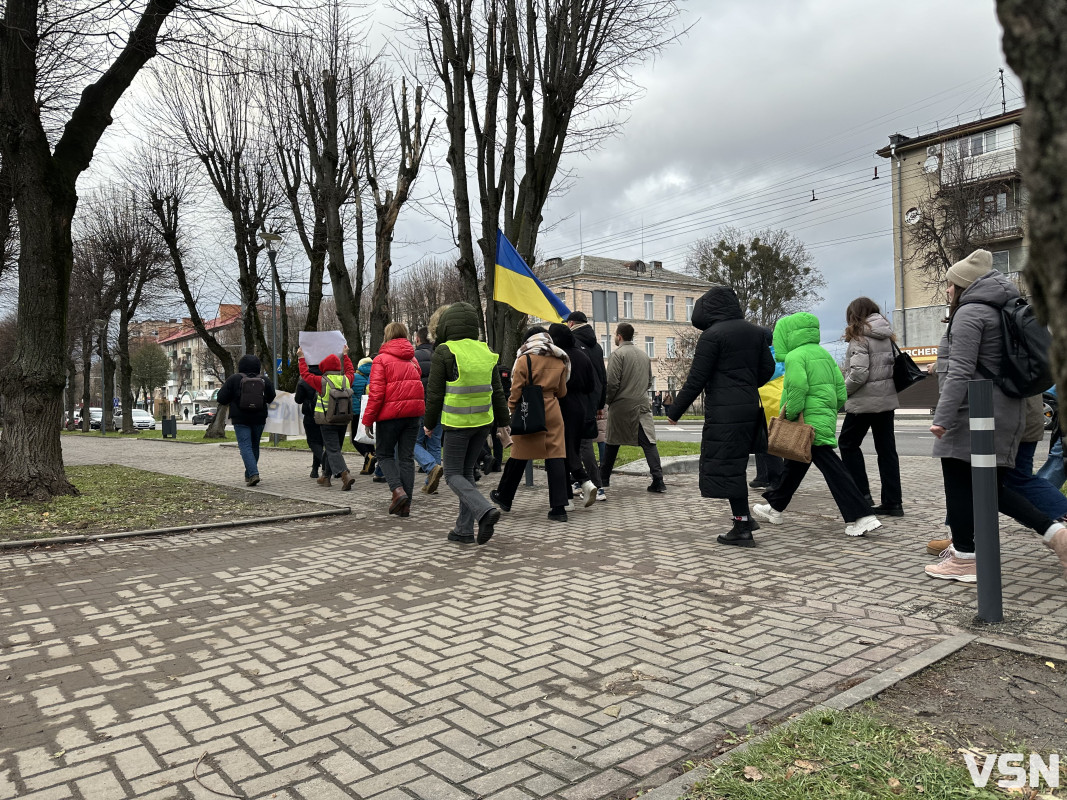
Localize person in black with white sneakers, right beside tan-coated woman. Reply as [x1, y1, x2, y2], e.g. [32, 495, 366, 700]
[548, 322, 596, 508]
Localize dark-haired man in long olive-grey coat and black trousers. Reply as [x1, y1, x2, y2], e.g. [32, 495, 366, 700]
[601, 322, 667, 493]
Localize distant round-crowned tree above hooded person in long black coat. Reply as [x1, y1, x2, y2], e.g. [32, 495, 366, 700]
[686, 226, 826, 327]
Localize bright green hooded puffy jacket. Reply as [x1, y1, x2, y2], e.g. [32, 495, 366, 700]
[775, 311, 848, 447]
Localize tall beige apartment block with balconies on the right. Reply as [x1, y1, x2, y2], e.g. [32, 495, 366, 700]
[877, 109, 1029, 363]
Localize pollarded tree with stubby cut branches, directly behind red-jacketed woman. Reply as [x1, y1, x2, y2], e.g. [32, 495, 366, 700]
[363, 78, 433, 352]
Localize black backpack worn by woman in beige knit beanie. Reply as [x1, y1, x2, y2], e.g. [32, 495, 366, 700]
[949, 298, 1054, 398]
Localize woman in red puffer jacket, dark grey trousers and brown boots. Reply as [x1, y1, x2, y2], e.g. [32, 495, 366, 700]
[363, 322, 426, 516]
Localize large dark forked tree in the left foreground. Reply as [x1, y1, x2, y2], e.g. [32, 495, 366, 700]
[0, 0, 309, 500]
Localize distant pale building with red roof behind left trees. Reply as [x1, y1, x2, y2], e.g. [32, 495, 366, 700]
[158, 304, 241, 419]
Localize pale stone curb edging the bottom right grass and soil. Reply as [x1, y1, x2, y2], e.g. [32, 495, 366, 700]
[641, 634, 977, 800]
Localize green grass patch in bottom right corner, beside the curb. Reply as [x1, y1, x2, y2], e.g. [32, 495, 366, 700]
[686, 710, 1004, 800]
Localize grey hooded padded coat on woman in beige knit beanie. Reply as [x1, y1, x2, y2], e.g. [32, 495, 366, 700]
[934, 270, 1025, 467]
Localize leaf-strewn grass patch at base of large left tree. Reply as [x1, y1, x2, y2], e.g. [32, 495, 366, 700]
[0, 464, 307, 541]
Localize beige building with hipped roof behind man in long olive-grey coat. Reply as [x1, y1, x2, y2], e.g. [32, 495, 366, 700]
[538, 255, 711, 394]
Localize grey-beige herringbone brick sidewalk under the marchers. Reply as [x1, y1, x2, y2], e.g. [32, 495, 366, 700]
[0, 439, 1067, 800]
